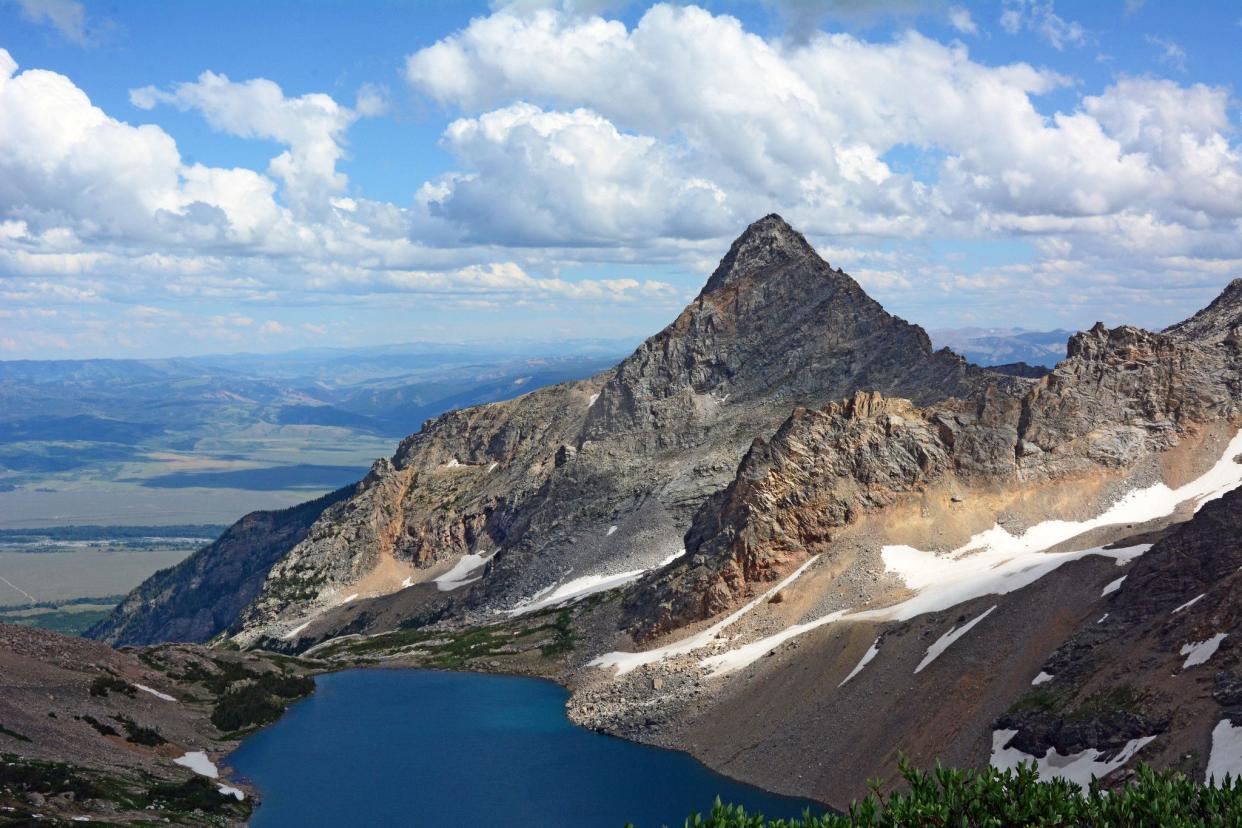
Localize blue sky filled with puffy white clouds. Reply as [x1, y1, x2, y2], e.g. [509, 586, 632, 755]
[0, 0, 1242, 359]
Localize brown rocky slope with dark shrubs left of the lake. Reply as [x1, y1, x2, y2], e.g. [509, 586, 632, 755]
[0, 624, 315, 826]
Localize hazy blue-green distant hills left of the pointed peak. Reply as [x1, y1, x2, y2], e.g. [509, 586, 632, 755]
[0, 340, 632, 501]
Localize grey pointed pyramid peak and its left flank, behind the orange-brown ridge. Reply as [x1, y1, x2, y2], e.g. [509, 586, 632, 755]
[91, 216, 995, 643]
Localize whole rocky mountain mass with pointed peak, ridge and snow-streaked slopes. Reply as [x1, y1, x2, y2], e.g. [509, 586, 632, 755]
[87, 216, 1242, 806]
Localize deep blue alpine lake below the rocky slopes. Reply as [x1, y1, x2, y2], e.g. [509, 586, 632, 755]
[226, 670, 809, 828]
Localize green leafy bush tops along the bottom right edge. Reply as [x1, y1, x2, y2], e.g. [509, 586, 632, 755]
[655, 762, 1242, 828]
